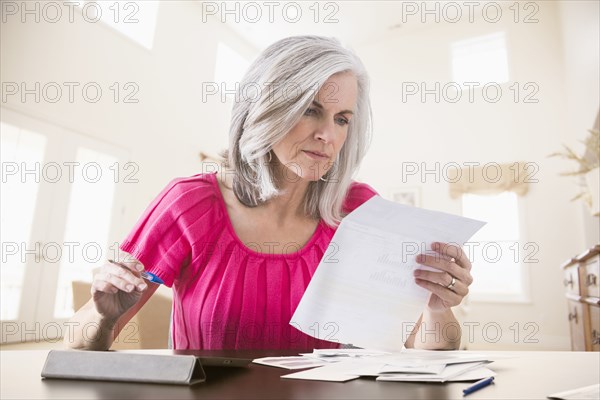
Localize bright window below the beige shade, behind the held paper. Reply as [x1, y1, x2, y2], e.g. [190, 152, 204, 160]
[462, 191, 537, 301]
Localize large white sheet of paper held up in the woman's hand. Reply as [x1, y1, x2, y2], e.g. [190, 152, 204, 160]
[290, 196, 485, 351]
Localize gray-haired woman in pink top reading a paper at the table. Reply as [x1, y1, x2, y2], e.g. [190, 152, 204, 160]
[65, 36, 472, 350]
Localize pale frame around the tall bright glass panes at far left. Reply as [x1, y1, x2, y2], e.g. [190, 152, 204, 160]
[0, 107, 130, 344]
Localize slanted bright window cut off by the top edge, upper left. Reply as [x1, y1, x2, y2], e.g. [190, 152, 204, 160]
[78, 0, 159, 50]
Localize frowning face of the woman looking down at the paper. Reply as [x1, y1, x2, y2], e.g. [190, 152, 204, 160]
[273, 72, 358, 181]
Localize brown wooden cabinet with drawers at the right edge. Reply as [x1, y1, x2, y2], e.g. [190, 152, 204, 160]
[561, 245, 600, 351]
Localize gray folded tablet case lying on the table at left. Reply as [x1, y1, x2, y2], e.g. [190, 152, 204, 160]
[42, 350, 206, 385]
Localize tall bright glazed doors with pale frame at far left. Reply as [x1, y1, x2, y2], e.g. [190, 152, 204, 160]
[0, 108, 129, 343]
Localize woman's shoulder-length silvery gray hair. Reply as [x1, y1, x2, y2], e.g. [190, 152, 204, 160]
[221, 35, 372, 226]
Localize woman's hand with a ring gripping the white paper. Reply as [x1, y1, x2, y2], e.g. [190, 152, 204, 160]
[414, 243, 473, 312]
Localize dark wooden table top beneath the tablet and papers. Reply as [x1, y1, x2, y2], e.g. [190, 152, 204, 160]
[0, 350, 600, 399]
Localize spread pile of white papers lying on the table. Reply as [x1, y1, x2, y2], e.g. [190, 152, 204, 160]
[254, 349, 496, 382]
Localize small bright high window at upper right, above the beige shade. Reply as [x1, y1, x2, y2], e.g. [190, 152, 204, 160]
[452, 32, 509, 86]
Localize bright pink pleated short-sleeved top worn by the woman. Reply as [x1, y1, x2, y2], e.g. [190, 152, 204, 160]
[120, 172, 377, 350]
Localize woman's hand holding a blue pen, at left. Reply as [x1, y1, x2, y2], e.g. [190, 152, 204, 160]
[91, 256, 148, 322]
